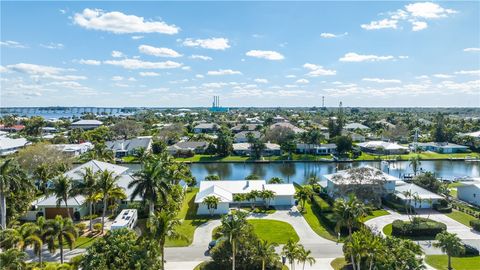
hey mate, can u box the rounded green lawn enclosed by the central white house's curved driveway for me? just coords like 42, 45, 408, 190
248, 219, 300, 244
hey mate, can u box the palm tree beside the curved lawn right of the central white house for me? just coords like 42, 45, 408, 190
333, 194, 367, 238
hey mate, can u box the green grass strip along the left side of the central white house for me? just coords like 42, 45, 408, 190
165, 188, 218, 247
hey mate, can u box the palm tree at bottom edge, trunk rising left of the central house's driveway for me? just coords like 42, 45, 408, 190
147, 211, 182, 270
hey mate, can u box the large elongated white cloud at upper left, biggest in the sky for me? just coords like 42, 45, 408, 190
73, 8, 180, 35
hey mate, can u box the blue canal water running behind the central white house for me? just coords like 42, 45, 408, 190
122, 160, 480, 184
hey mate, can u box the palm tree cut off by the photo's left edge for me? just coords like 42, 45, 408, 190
0, 159, 34, 229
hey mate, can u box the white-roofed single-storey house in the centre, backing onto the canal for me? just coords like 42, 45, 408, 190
195, 180, 295, 215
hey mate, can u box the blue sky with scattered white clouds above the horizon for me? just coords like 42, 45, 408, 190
0, 1, 480, 107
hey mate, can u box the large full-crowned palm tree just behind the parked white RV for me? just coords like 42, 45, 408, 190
128, 159, 170, 215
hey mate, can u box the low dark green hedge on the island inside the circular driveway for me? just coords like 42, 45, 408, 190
392, 217, 447, 237
